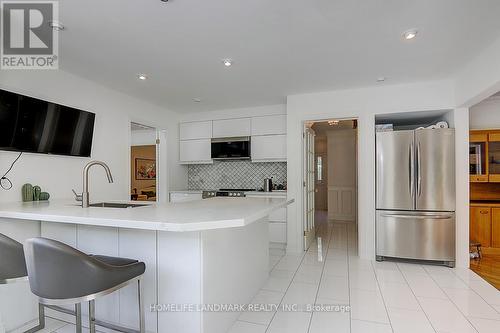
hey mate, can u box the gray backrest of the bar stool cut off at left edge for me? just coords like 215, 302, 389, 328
0, 234, 28, 284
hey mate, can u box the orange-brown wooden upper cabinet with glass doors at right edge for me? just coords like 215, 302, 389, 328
469, 130, 500, 183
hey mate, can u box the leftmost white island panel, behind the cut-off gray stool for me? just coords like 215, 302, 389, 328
0, 218, 40, 332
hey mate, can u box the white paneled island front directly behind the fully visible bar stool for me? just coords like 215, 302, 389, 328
42, 222, 157, 332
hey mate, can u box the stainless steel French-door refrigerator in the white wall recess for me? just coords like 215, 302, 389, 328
376, 128, 455, 266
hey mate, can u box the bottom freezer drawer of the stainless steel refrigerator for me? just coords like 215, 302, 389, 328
376, 210, 455, 262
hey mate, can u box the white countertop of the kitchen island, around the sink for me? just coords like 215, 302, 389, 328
0, 197, 293, 232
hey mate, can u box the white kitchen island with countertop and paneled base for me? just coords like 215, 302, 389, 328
0, 198, 291, 333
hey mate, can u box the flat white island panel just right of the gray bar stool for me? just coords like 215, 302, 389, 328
157, 231, 203, 333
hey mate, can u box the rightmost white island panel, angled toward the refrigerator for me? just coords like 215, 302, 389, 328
202, 217, 269, 333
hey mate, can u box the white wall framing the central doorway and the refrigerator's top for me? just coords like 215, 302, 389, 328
287, 81, 455, 259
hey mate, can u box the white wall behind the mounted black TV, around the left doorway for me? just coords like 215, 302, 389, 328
0, 70, 187, 201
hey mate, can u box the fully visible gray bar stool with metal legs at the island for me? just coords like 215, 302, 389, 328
24, 237, 146, 333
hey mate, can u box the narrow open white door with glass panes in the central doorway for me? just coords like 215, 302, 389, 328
303, 128, 316, 250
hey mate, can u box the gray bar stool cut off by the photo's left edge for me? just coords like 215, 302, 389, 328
0, 234, 45, 333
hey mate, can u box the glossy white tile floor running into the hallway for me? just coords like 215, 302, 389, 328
12, 218, 500, 333
